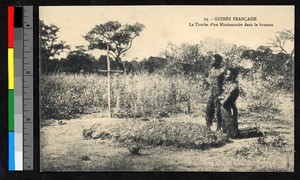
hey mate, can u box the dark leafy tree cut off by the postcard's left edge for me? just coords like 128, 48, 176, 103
39, 20, 70, 73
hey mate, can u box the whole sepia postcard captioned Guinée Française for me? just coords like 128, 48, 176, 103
39, 5, 295, 172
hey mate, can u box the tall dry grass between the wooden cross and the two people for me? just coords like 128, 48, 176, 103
112, 73, 206, 117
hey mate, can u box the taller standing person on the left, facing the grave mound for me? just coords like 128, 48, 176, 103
205, 54, 225, 131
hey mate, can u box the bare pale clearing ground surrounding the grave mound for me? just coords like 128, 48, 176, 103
40, 96, 294, 172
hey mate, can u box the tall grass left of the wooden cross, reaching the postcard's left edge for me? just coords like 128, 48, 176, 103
40, 74, 107, 120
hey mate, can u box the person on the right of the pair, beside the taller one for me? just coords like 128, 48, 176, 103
219, 68, 240, 138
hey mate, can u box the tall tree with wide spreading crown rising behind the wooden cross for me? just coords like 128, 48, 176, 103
83, 21, 145, 63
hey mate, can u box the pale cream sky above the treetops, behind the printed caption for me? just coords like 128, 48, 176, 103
39, 6, 294, 60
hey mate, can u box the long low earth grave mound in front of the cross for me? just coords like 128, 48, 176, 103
83, 120, 230, 149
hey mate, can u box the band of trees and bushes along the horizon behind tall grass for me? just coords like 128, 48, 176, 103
40, 21, 294, 92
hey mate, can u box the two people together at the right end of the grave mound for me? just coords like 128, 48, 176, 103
205, 54, 239, 138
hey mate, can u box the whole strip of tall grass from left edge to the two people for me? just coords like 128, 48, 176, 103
40, 73, 207, 119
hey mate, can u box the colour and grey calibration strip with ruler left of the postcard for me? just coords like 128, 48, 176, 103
8, 6, 33, 171
